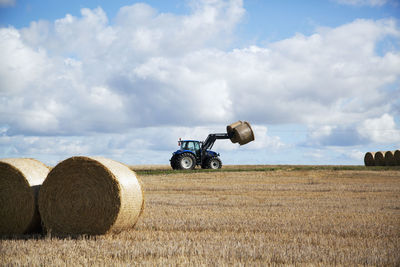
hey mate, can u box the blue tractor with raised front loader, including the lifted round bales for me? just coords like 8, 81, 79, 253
170, 121, 254, 170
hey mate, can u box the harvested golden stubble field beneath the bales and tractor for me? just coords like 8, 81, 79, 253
0, 166, 400, 266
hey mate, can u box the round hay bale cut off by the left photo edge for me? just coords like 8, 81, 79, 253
0, 158, 49, 235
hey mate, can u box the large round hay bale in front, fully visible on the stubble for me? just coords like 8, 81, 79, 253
39, 157, 144, 235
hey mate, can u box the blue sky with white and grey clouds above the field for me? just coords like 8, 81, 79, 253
0, 0, 400, 165
